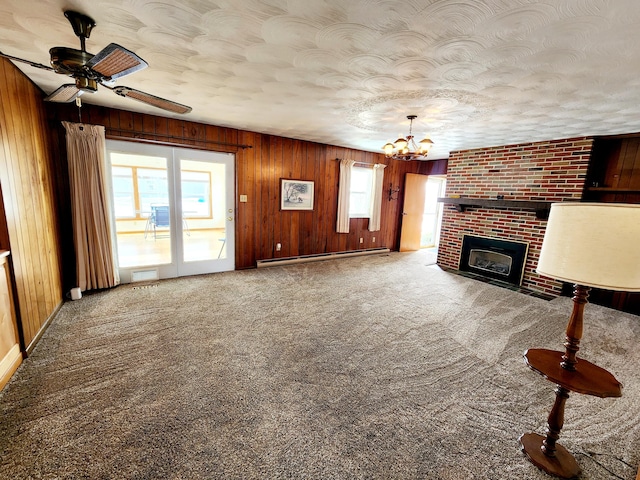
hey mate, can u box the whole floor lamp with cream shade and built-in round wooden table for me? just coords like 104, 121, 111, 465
520, 202, 640, 478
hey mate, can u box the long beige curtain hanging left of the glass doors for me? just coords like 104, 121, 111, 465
62, 122, 120, 291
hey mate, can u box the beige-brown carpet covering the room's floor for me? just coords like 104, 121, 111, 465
0, 252, 640, 480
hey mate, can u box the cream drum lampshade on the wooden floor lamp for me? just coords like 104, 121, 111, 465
536, 202, 640, 292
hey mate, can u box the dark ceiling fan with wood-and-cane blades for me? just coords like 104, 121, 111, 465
0, 10, 191, 113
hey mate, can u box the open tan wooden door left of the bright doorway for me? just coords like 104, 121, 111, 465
400, 173, 428, 252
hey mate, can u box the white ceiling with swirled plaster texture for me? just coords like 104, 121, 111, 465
0, 0, 640, 158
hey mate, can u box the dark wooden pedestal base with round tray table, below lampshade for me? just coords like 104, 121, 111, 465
519, 285, 622, 478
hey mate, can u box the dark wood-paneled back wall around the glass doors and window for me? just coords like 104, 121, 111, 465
48, 105, 446, 269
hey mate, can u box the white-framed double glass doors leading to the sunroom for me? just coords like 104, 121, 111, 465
107, 140, 235, 283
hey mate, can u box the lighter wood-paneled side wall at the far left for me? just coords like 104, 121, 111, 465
0, 58, 63, 350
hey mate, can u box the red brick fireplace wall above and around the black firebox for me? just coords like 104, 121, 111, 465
438, 137, 593, 295
